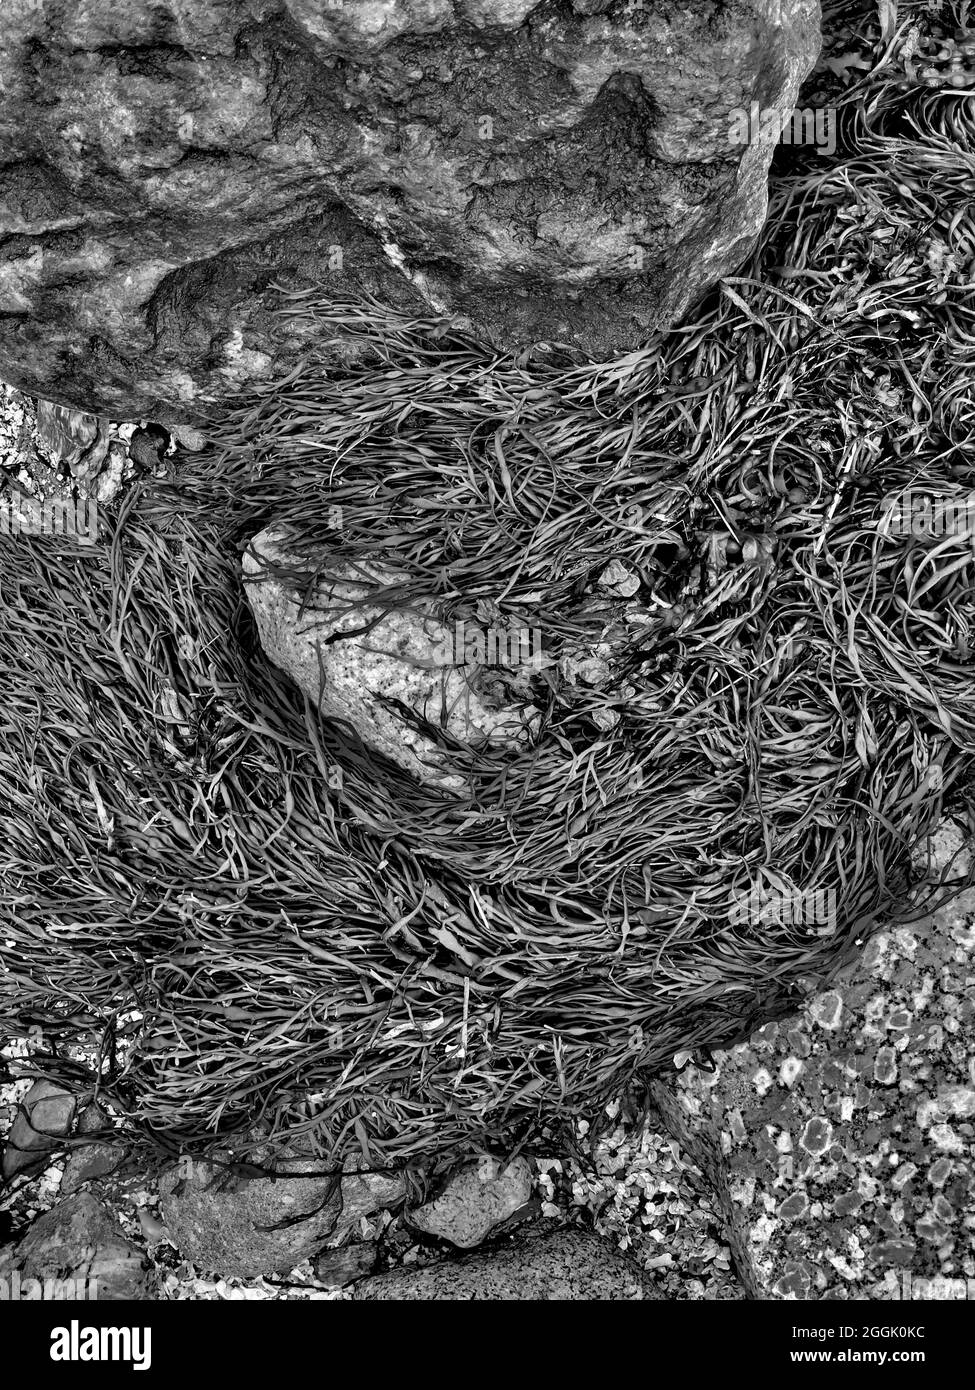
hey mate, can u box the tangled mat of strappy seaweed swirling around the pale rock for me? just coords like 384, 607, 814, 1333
0, 0, 975, 1166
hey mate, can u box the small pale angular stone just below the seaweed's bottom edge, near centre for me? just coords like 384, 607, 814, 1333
409, 1158, 533, 1250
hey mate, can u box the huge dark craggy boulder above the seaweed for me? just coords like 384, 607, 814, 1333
0, 0, 819, 423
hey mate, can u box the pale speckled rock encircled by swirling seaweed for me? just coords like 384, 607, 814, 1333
243, 531, 533, 792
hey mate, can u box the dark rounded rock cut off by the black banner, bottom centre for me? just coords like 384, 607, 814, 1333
355, 1227, 659, 1302
